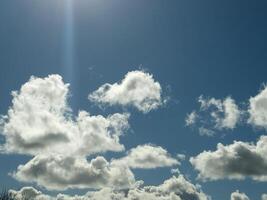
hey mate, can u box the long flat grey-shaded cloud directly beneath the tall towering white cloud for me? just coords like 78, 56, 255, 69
13, 154, 135, 190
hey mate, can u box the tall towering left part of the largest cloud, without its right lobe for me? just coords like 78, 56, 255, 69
3, 75, 70, 153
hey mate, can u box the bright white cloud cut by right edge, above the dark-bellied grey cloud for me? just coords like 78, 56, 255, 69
248, 86, 267, 130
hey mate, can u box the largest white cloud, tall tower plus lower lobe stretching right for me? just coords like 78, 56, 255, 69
2, 75, 129, 155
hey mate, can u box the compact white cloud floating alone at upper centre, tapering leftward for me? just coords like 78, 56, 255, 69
88, 71, 163, 113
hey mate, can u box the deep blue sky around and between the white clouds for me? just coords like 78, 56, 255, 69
0, 0, 267, 200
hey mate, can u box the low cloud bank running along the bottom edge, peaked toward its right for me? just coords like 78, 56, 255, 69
8, 175, 209, 200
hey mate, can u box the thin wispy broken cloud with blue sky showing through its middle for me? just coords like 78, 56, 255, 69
185, 96, 241, 136
